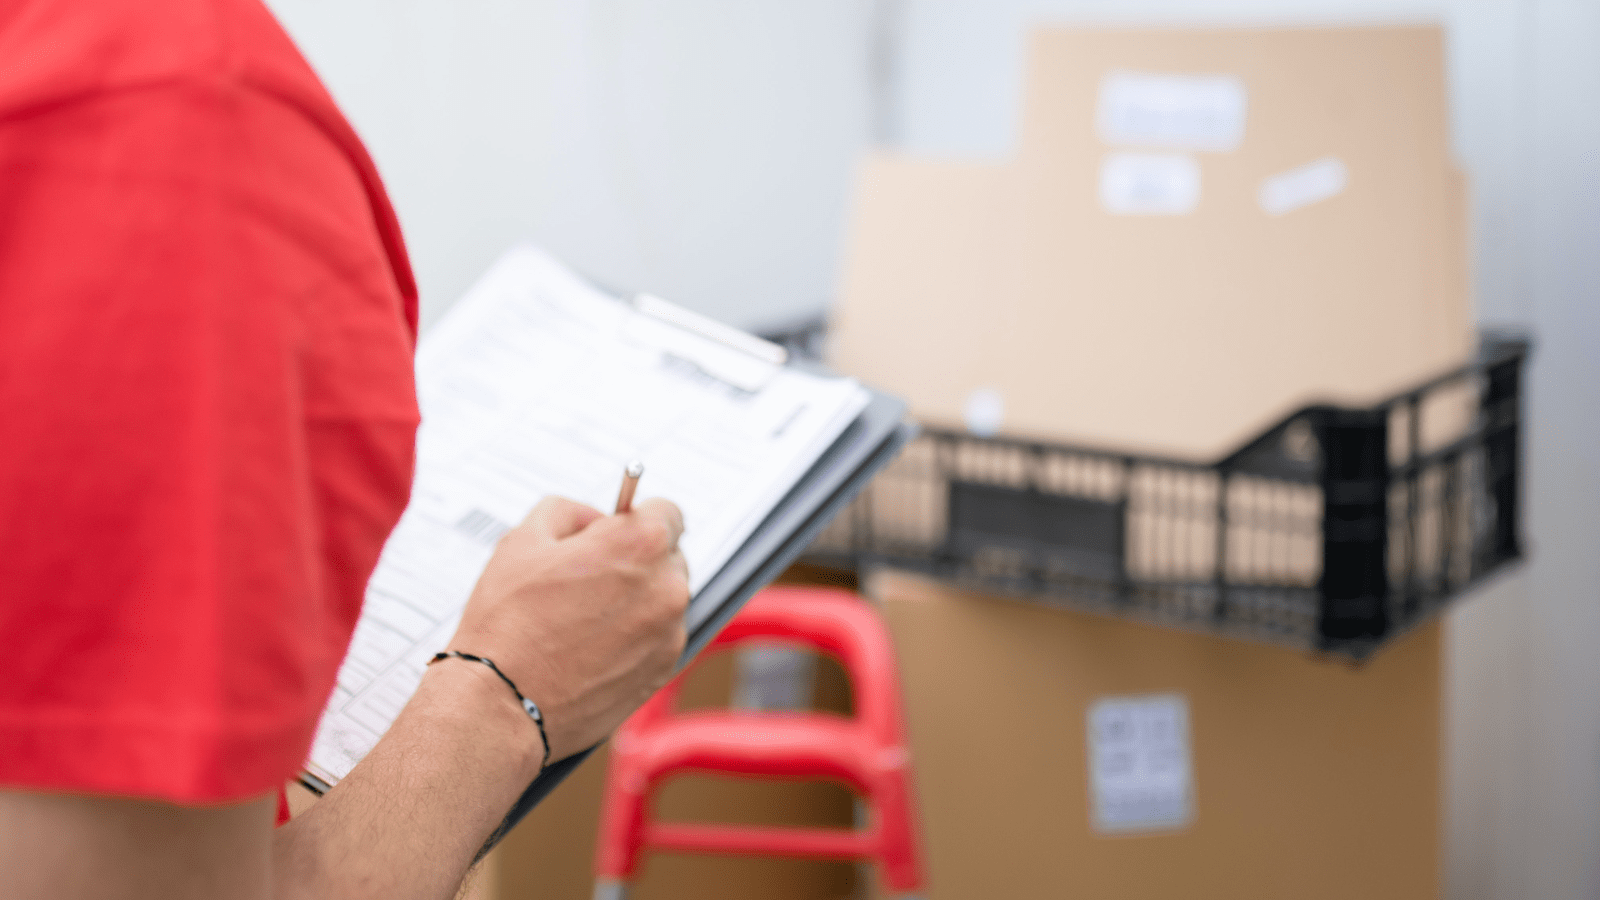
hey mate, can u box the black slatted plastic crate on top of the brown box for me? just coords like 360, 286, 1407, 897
810, 335, 1528, 658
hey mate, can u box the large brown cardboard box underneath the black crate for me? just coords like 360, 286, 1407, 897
867, 572, 1440, 900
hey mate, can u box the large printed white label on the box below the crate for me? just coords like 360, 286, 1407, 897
1088, 693, 1194, 833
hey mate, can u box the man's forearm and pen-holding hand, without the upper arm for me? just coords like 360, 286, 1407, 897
275, 500, 690, 900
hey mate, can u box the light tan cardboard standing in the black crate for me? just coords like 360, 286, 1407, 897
834, 27, 1472, 460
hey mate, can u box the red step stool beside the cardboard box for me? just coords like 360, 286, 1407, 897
595, 586, 923, 900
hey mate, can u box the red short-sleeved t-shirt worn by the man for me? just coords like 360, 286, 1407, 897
0, 0, 418, 802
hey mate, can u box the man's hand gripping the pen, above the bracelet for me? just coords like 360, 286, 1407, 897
440, 498, 690, 761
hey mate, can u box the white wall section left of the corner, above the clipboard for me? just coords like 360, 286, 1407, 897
269, 0, 874, 327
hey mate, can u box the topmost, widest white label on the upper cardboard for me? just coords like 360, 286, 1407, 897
1096, 72, 1248, 151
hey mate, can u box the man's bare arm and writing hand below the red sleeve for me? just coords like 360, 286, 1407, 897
0, 500, 688, 900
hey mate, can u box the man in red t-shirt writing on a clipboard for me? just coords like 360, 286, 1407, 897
0, 0, 688, 900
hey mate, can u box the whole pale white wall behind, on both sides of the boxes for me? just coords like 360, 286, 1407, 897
272, 0, 1600, 900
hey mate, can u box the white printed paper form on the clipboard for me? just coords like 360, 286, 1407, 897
307, 248, 869, 785
